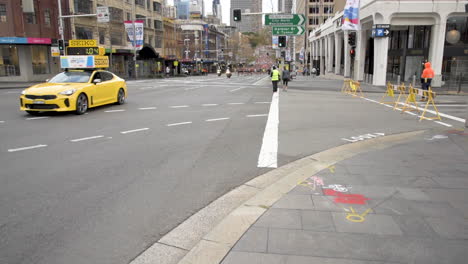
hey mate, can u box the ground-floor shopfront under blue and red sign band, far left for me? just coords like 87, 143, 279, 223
0, 37, 60, 82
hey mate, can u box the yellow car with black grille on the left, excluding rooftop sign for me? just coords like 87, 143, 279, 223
20, 70, 127, 115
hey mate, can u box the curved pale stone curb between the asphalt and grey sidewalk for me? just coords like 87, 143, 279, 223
130, 130, 425, 264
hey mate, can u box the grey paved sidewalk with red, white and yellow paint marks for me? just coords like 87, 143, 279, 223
222, 130, 468, 264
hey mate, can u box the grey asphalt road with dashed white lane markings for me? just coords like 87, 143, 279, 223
0, 75, 466, 264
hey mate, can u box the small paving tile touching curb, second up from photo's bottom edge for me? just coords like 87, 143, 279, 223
233, 226, 268, 252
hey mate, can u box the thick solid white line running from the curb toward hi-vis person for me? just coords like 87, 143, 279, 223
257, 93, 279, 168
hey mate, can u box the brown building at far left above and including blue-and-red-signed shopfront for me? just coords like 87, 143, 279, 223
0, 0, 67, 82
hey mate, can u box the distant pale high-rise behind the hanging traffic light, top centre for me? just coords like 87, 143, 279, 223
230, 0, 262, 32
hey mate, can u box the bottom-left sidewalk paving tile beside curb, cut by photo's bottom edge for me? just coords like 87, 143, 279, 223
221, 251, 286, 264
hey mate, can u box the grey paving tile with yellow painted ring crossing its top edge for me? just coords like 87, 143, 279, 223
332, 212, 403, 236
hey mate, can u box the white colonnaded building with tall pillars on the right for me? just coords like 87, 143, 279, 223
309, 0, 468, 87
